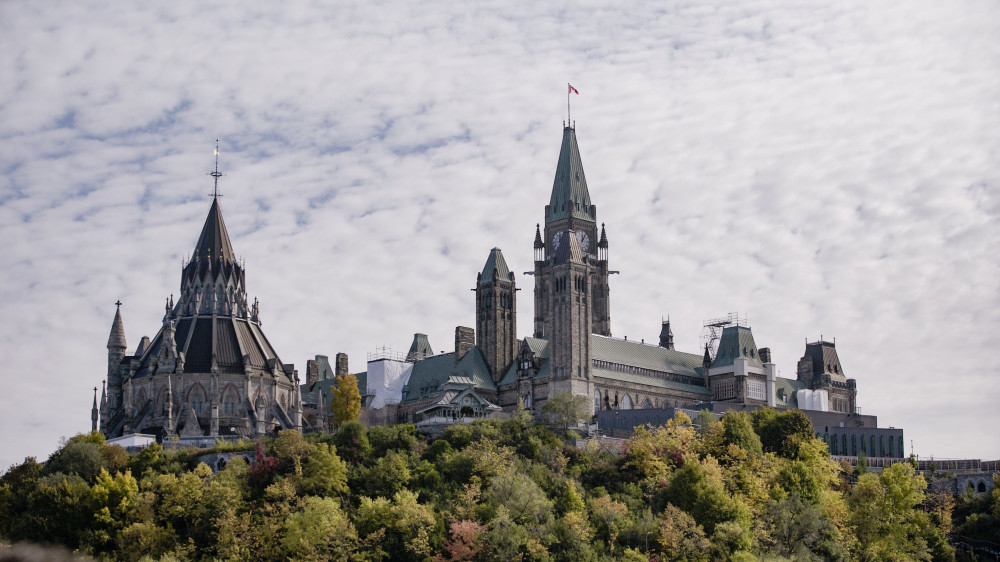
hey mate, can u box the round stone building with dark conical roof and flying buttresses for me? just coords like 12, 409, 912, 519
95, 172, 302, 440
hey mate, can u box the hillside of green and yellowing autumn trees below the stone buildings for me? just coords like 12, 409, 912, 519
0, 404, 1000, 561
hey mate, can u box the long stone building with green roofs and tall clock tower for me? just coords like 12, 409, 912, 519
374, 122, 868, 425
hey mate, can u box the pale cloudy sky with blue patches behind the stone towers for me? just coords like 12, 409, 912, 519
0, 0, 1000, 470
